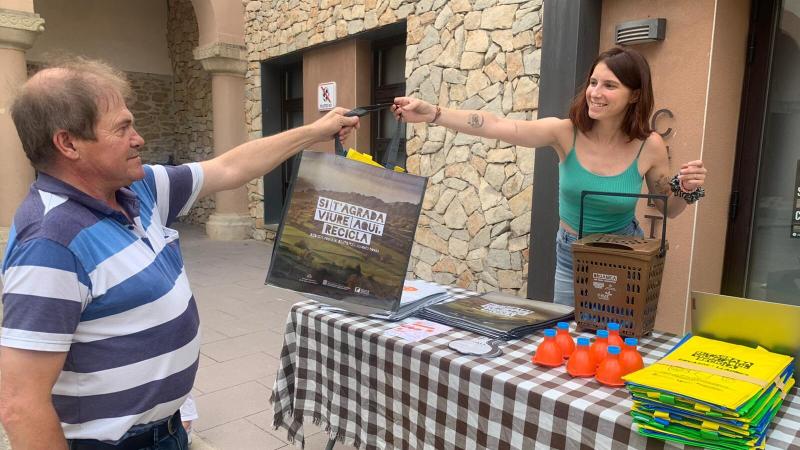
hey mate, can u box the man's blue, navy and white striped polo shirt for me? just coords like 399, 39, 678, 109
0, 163, 203, 442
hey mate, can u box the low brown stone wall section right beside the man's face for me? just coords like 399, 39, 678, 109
126, 72, 177, 164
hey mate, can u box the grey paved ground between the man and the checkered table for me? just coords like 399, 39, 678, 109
0, 225, 352, 450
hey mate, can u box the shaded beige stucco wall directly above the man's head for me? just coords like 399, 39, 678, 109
27, 0, 172, 74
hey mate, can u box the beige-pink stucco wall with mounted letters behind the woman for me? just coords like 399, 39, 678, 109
600, 0, 749, 333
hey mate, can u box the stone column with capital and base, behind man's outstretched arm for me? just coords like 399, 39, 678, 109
194, 42, 253, 240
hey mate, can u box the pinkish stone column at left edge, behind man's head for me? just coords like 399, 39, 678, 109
0, 7, 44, 258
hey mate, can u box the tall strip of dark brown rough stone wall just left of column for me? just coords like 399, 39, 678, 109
167, 0, 215, 224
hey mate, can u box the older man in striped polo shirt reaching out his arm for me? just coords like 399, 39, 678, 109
0, 60, 358, 450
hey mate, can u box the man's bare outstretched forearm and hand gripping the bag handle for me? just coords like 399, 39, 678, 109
200, 108, 358, 197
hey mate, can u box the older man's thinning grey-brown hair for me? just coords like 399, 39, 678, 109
11, 57, 131, 169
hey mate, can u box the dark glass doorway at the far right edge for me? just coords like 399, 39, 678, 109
722, 0, 800, 305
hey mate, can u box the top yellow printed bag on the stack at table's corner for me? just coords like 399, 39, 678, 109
623, 336, 792, 410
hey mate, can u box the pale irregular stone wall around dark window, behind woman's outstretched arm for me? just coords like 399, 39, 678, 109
244, 0, 542, 296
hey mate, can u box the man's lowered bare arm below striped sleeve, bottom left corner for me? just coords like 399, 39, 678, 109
0, 347, 67, 450
